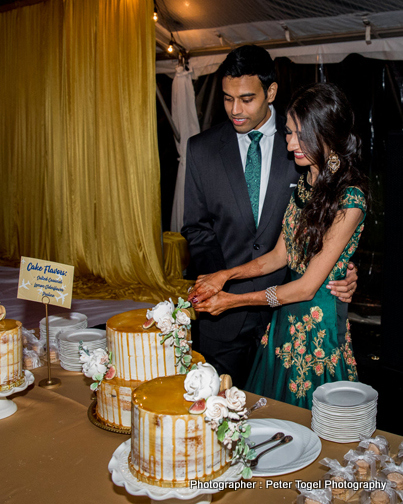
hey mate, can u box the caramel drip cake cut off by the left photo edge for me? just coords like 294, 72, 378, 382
0, 319, 25, 392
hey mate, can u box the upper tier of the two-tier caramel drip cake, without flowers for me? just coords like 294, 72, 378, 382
106, 309, 190, 382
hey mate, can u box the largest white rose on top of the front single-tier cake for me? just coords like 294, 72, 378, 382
183, 362, 220, 401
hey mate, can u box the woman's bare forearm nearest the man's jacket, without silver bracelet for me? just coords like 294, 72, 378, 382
188, 233, 287, 303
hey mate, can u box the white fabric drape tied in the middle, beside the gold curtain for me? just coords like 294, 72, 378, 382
171, 67, 200, 232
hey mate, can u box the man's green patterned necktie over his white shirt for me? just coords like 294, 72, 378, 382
245, 131, 263, 229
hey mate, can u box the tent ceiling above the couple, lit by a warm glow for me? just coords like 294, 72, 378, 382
156, 0, 403, 59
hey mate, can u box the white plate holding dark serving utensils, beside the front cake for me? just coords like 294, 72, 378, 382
249, 418, 322, 477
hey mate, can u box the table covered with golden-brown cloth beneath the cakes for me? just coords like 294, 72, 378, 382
0, 364, 403, 504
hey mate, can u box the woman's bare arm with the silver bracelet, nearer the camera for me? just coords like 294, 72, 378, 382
195, 208, 363, 315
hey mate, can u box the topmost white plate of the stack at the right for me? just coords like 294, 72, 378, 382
313, 381, 378, 408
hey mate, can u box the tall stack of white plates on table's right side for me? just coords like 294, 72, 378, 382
311, 381, 378, 443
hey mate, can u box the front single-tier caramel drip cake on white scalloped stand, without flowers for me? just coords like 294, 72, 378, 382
129, 375, 231, 488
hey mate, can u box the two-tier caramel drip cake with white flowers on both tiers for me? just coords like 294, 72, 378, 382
81, 298, 195, 430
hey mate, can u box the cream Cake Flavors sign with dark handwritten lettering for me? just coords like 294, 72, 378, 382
17, 257, 74, 308
